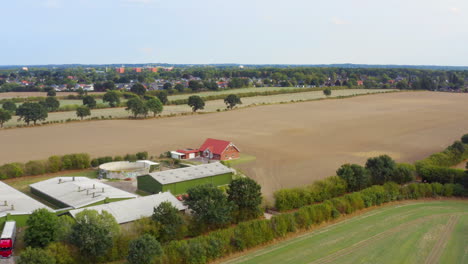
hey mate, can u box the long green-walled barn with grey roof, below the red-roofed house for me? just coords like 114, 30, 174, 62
137, 162, 234, 194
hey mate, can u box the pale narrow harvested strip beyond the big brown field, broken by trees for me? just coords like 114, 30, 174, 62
0, 88, 395, 127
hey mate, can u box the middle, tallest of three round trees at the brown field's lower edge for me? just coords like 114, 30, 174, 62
366, 155, 397, 184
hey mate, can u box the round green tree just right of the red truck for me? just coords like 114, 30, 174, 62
24, 208, 59, 248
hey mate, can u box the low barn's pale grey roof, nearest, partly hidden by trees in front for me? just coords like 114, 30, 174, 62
70, 192, 186, 224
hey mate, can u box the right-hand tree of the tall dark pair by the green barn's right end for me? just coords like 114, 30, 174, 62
227, 177, 262, 222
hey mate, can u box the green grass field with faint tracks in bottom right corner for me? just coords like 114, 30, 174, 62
225, 200, 468, 264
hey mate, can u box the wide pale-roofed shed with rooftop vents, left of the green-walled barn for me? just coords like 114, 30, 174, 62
29, 177, 137, 208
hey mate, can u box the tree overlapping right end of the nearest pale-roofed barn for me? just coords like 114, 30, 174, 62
152, 202, 185, 242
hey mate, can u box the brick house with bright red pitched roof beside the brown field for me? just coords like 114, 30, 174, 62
199, 138, 240, 160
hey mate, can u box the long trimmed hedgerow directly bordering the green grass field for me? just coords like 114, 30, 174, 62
158, 182, 465, 264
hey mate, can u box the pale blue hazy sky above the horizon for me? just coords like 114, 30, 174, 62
0, 0, 468, 66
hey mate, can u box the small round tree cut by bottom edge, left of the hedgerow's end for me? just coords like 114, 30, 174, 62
127, 234, 162, 264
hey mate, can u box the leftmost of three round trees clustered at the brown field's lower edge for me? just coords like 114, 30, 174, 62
336, 164, 371, 192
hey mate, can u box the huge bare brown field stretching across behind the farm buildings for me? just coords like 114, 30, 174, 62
0, 92, 468, 195
